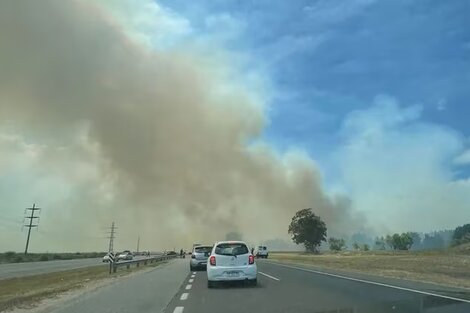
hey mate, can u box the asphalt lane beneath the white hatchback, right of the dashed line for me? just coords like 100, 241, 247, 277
166, 261, 470, 313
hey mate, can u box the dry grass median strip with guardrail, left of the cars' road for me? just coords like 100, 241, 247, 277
0, 262, 162, 312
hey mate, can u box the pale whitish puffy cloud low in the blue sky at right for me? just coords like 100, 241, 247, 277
338, 97, 470, 231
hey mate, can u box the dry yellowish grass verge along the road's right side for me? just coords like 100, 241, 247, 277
270, 250, 470, 289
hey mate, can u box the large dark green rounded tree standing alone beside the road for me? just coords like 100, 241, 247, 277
288, 208, 326, 252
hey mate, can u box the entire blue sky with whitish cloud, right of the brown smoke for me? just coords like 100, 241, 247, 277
149, 0, 470, 230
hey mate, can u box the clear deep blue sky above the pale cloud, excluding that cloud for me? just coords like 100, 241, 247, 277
158, 0, 470, 180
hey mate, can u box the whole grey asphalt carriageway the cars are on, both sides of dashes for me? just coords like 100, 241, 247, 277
7, 259, 470, 313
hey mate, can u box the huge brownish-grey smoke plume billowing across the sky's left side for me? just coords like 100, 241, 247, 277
0, 1, 360, 250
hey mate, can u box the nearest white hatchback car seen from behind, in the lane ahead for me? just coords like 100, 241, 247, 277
207, 241, 258, 288
